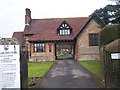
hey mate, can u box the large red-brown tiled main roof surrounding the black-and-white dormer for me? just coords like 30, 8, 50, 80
24, 17, 91, 41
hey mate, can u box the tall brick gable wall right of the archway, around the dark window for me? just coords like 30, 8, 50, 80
75, 20, 101, 60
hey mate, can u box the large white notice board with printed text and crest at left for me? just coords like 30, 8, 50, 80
0, 45, 20, 90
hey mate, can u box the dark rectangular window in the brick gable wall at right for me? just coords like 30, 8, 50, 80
89, 33, 98, 46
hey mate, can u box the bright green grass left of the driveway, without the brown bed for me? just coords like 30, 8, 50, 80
28, 62, 53, 78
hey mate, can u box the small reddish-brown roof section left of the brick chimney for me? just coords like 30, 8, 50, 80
12, 32, 25, 46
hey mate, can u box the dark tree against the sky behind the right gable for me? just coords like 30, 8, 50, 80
95, 0, 120, 24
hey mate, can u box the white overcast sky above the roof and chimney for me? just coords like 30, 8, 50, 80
0, 0, 111, 38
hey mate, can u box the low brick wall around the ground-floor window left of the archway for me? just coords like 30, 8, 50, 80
29, 43, 55, 62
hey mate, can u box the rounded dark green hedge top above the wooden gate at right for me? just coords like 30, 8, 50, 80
99, 24, 120, 47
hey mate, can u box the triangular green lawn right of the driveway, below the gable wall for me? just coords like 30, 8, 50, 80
79, 60, 104, 79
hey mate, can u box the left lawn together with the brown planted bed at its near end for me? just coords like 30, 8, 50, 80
28, 62, 54, 87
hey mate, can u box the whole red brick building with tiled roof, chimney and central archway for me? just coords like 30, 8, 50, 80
13, 9, 103, 62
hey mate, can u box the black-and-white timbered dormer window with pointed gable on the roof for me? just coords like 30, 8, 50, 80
57, 21, 72, 36
